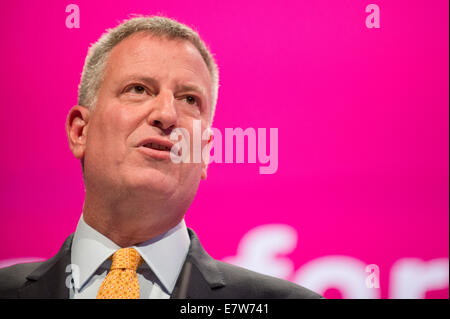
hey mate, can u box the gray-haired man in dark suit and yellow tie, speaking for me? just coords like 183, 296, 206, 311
0, 17, 320, 299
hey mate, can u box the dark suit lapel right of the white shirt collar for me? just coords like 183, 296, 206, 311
171, 228, 226, 299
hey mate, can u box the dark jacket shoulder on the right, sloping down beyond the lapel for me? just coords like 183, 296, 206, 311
216, 260, 323, 299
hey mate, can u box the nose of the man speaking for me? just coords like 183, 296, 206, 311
147, 91, 178, 135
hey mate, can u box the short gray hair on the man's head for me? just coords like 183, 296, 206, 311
78, 16, 219, 125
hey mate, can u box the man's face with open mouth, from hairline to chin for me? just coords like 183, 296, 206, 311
80, 33, 211, 208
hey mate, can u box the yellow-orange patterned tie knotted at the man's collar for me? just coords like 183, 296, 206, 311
97, 248, 143, 299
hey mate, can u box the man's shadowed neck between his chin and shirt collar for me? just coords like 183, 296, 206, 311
83, 194, 184, 248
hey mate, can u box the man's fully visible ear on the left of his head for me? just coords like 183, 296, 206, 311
66, 105, 90, 160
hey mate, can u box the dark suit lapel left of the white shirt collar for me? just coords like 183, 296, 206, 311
19, 234, 73, 299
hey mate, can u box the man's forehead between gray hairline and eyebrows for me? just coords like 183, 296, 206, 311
105, 32, 212, 95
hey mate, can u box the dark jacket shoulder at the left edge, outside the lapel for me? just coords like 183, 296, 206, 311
0, 262, 42, 298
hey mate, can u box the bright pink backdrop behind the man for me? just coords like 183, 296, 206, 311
0, 0, 449, 298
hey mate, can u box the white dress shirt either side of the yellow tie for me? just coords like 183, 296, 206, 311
68, 215, 191, 299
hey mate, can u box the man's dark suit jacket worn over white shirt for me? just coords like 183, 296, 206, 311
0, 229, 321, 299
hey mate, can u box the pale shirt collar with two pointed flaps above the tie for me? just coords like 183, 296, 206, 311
71, 215, 190, 293
